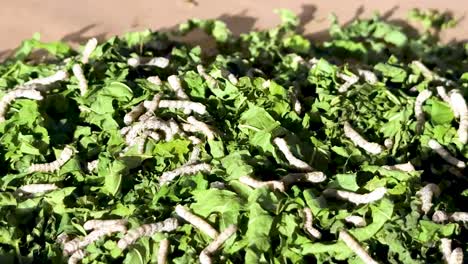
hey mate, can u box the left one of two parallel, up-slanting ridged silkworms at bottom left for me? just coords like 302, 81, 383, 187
63, 225, 127, 256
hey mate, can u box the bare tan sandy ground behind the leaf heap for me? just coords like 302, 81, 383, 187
0, 0, 468, 57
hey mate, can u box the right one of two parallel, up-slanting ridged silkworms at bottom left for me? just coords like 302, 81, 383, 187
117, 218, 179, 250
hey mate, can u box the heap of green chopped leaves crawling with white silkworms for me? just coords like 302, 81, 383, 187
0, 10, 468, 264
